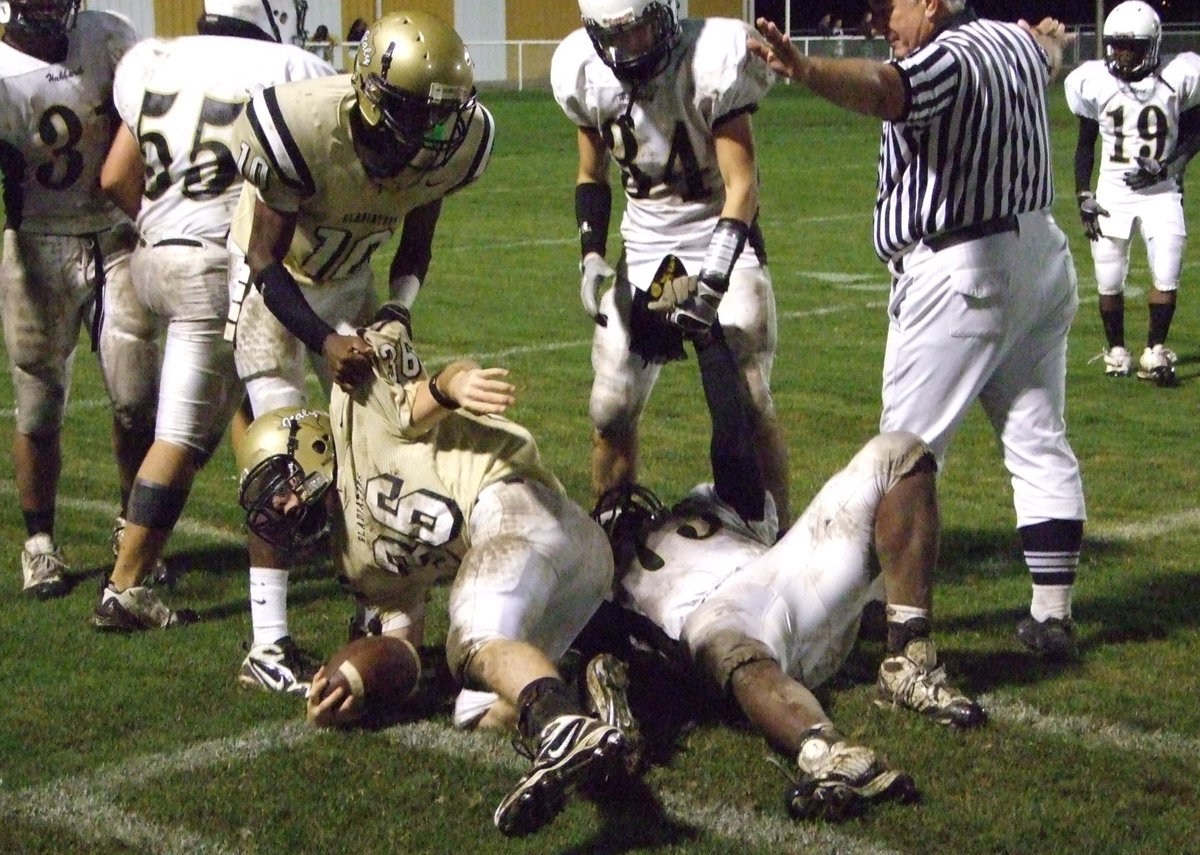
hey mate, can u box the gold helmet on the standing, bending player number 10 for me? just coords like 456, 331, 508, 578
352, 12, 475, 169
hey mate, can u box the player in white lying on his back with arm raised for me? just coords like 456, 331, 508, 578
593, 324, 986, 819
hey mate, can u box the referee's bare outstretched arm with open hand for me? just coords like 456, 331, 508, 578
746, 18, 905, 121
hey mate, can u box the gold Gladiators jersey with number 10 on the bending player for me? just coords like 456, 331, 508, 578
226, 74, 494, 285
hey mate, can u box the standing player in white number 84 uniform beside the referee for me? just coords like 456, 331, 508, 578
551, 0, 788, 527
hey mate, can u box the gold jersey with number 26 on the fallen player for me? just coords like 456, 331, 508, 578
329, 321, 563, 611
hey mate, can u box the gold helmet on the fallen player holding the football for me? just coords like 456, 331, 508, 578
238, 407, 335, 551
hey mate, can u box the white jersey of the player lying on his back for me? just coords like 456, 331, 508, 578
617, 484, 778, 641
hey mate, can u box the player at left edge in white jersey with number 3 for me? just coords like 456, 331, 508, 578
0, 0, 158, 598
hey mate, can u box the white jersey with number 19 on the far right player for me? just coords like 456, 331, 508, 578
1064, 53, 1200, 198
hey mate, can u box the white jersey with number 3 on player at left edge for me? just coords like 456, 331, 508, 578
0, 12, 137, 235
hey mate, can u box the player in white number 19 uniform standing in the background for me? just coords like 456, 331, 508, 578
1066, 0, 1200, 385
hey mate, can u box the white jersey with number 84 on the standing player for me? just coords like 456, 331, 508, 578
551, 18, 774, 289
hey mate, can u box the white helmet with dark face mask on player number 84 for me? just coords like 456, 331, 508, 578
580, 0, 680, 82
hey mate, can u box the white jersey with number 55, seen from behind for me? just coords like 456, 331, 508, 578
113, 36, 336, 245
